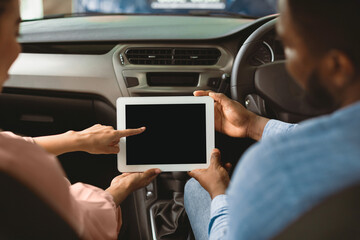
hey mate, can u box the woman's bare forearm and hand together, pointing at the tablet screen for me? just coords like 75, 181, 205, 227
33, 124, 145, 155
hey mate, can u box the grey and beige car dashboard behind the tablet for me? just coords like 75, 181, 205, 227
5, 16, 284, 106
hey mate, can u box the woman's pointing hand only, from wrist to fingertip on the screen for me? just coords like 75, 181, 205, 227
77, 124, 145, 154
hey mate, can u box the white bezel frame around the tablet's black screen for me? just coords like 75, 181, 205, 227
116, 96, 215, 172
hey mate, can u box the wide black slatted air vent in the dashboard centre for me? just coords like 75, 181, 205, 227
125, 48, 221, 65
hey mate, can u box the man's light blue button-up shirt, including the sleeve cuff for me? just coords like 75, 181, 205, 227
209, 103, 360, 240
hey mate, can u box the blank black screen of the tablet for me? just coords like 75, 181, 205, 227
125, 103, 206, 165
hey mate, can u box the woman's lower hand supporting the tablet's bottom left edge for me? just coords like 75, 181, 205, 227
105, 168, 161, 206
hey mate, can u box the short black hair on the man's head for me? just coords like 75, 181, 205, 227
287, 0, 360, 72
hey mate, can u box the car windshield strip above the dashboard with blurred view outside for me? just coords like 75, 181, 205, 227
21, 0, 277, 20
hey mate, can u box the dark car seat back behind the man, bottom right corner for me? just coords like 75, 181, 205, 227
274, 184, 360, 240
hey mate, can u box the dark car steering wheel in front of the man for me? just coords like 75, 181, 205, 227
230, 18, 323, 122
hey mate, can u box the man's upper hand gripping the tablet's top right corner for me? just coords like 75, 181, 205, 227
194, 91, 269, 140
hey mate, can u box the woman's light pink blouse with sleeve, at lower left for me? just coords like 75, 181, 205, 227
0, 132, 121, 240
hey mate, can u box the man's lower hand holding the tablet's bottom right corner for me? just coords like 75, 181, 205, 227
189, 149, 231, 199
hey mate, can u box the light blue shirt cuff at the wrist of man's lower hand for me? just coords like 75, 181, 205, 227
209, 195, 229, 240
